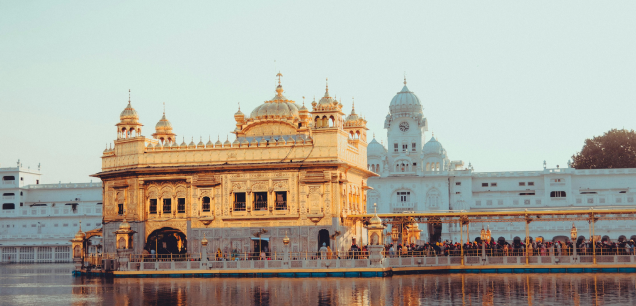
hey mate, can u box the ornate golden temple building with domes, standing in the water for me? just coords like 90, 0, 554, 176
94, 74, 377, 254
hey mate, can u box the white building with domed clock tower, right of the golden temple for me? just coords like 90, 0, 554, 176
367, 82, 636, 241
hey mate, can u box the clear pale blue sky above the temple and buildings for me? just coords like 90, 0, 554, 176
0, 1, 636, 183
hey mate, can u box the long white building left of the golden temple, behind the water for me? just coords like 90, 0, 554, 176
0, 162, 102, 262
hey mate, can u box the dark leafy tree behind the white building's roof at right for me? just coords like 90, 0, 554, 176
572, 129, 636, 169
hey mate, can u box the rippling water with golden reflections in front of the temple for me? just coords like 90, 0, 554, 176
0, 264, 636, 306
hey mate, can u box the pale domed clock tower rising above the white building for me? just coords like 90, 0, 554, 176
384, 79, 428, 176
